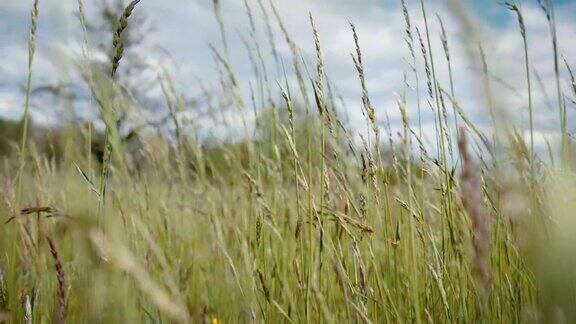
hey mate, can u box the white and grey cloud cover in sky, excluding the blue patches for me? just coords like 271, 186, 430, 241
0, 0, 576, 151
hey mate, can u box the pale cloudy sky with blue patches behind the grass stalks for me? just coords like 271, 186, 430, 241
0, 0, 576, 151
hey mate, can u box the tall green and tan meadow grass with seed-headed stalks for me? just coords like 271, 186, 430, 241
0, 1, 576, 323
